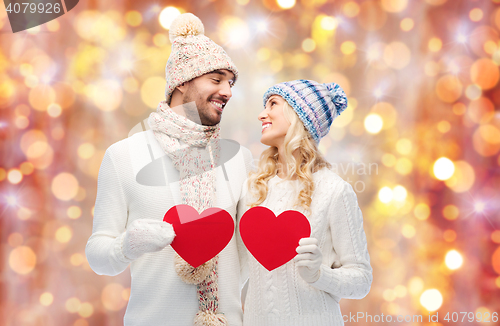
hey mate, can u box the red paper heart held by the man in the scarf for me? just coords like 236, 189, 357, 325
163, 205, 234, 267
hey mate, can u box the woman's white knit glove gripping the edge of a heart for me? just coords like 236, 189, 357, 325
293, 238, 323, 283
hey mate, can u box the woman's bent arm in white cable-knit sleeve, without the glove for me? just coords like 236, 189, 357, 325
310, 180, 373, 299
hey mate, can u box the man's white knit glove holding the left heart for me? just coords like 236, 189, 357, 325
122, 219, 175, 260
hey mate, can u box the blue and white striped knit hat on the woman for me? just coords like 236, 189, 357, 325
264, 79, 347, 144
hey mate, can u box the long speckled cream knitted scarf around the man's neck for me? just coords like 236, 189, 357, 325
148, 101, 227, 326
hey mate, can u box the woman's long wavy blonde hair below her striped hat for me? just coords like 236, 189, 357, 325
248, 101, 331, 213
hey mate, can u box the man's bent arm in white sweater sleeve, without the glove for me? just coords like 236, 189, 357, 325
85, 149, 132, 276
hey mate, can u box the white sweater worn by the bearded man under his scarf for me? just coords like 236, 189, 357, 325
86, 130, 252, 326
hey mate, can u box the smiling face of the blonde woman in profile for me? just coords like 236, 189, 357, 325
259, 95, 290, 147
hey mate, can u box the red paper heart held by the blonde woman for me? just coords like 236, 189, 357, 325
240, 206, 311, 271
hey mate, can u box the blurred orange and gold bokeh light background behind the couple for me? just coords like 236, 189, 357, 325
0, 0, 500, 326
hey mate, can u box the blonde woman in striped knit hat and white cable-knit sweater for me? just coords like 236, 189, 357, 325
243, 80, 372, 326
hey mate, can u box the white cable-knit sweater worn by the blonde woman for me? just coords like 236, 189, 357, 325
238, 168, 372, 326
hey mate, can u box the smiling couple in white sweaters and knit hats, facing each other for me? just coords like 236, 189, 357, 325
86, 14, 372, 326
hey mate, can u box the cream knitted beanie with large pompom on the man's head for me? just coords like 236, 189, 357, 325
165, 13, 238, 104
